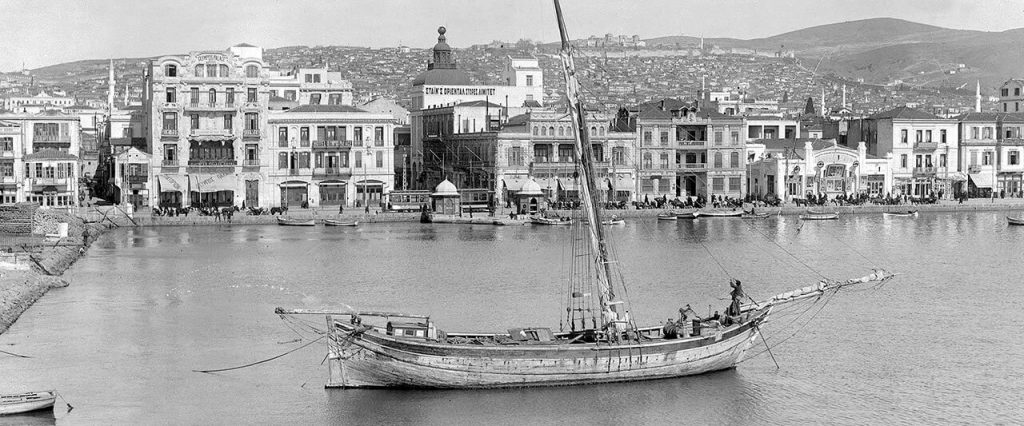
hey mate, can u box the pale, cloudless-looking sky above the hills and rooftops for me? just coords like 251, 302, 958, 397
0, 0, 1024, 71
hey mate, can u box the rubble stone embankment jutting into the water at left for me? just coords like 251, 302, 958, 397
0, 210, 108, 334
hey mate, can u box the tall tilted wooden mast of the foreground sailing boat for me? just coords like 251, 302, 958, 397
554, 0, 617, 324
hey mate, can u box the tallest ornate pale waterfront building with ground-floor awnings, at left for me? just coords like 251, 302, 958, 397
143, 45, 276, 207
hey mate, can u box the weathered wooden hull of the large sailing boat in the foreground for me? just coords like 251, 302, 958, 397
327, 310, 768, 388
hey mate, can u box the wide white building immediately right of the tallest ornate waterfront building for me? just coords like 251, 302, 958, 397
266, 104, 395, 208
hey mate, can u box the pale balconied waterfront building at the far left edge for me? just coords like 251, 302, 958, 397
0, 111, 81, 207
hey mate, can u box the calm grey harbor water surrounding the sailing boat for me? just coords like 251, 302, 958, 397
0, 212, 1024, 424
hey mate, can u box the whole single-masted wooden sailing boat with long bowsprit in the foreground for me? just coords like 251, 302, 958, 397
275, 0, 892, 388
